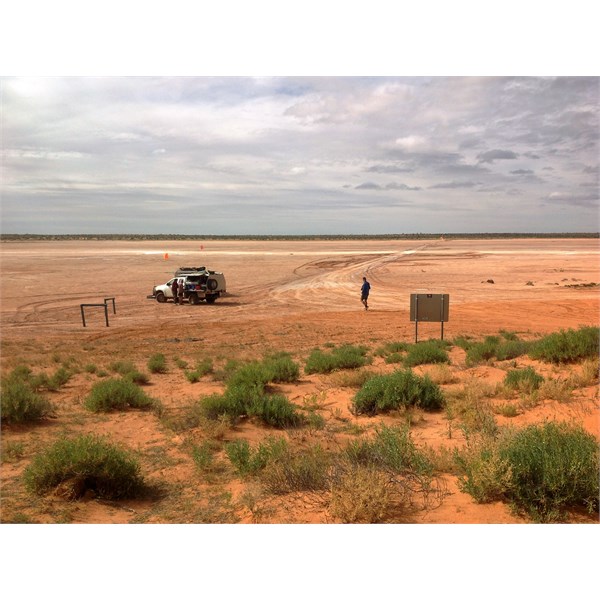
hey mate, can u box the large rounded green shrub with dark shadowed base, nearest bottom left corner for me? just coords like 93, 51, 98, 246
24, 435, 143, 499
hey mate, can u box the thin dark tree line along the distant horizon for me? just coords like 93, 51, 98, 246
0, 232, 600, 242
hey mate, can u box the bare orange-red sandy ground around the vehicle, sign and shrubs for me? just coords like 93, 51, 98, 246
0, 239, 600, 524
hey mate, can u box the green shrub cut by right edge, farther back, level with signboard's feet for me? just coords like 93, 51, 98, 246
529, 327, 600, 364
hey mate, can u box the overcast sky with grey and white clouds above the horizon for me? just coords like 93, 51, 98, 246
1, 76, 600, 235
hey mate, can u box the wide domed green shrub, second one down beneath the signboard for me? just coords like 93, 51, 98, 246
353, 369, 444, 414
